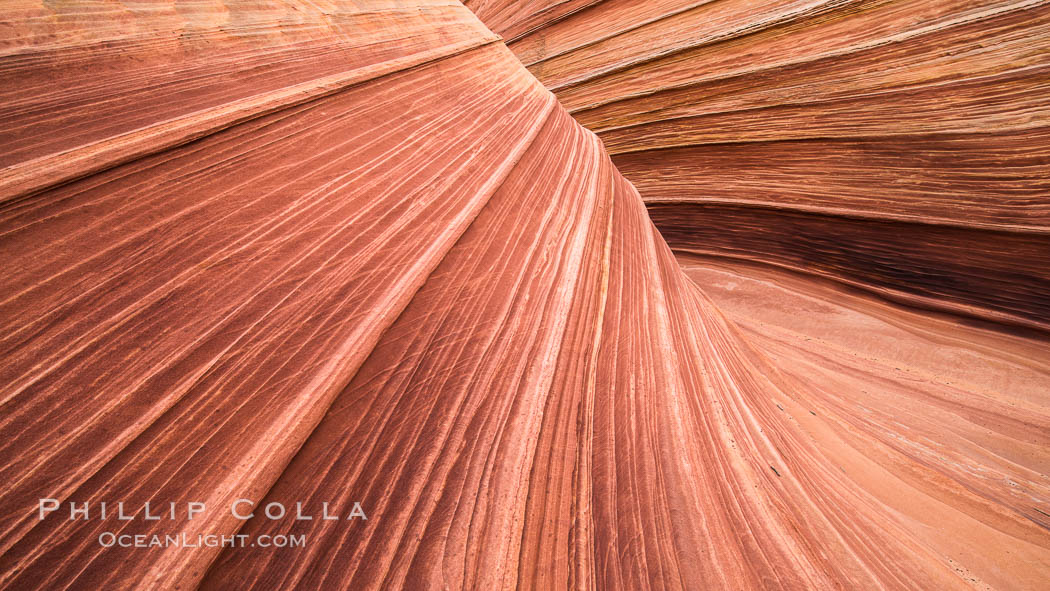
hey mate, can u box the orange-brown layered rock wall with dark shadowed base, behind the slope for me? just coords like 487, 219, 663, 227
466, 0, 1050, 331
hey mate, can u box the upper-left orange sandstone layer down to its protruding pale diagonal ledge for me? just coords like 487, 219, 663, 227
0, 0, 499, 199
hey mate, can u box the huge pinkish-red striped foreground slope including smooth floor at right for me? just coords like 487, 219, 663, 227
0, 0, 1050, 590
